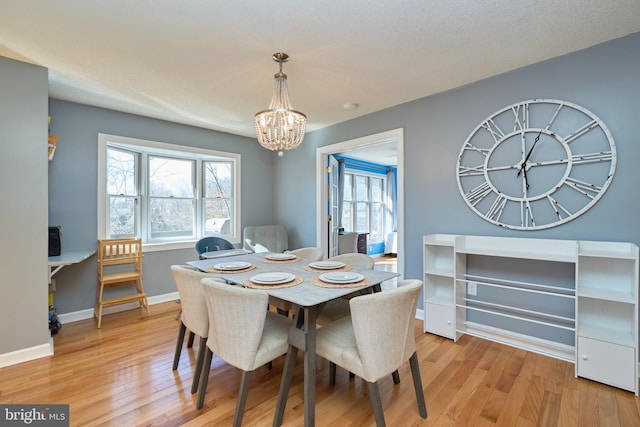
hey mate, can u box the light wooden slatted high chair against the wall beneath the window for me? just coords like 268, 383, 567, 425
95, 238, 150, 328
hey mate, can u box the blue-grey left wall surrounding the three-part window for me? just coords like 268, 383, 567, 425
49, 99, 277, 314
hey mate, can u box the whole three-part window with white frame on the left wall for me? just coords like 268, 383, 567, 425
98, 134, 240, 250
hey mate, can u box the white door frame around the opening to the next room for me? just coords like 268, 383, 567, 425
316, 128, 404, 278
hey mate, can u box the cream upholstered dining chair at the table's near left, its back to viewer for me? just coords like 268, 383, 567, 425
197, 279, 293, 426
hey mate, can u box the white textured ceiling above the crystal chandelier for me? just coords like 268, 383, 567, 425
0, 0, 640, 150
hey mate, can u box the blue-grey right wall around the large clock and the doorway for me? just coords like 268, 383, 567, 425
275, 33, 640, 284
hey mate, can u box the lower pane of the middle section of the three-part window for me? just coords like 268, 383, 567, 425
149, 198, 195, 239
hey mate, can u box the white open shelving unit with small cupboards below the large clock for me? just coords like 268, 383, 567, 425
423, 234, 638, 395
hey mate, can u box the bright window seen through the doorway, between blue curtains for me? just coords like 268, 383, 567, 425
342, 173, 385, 240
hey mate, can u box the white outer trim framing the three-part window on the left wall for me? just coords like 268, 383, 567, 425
97, 133, 242, 252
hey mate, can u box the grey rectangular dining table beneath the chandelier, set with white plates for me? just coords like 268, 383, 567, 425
187, 253, 399, 426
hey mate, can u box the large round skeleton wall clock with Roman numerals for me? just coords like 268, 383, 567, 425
456, 99, 616, 230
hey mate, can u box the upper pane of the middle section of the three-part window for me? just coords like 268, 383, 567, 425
149, 156, 195, 197
